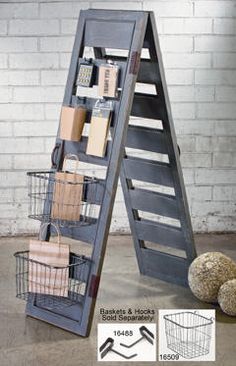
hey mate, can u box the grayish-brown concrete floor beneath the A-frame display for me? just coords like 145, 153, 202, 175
0, 234, 236, 366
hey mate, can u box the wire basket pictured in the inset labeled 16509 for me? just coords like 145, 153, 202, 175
164, 311, 213, 358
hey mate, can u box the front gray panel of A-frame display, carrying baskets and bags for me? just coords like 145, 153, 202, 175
26, 10, 148, 336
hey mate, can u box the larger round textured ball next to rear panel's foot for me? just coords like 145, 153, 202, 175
188, 252, 236, 302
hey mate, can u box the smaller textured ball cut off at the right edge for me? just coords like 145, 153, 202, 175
218, 279, 236, 316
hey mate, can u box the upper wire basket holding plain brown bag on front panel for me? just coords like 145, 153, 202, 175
27, 170, 99, 227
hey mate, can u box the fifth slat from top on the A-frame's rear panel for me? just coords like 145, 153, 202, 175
123, 156, 174, 187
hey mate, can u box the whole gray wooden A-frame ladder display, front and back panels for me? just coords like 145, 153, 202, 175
26, 9, 196, 336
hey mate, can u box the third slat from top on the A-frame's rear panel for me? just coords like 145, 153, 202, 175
131, 93, 165, 120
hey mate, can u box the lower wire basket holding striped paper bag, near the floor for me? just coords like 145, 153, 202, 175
14, 251, 90, 309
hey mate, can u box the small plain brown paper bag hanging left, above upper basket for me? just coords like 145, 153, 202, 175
60, 106, 86, 141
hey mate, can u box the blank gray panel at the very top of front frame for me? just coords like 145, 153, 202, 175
84, 19, 134, 50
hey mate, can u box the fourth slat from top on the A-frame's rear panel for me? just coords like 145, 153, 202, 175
126, 125, 168, 154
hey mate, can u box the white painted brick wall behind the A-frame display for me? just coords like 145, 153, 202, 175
0, 0, 236, 235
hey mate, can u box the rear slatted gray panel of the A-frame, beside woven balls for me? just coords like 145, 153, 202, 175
119, 9, 196, 292
